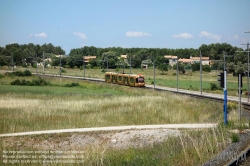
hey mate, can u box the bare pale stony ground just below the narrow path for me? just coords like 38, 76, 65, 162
3, 129, 180, 151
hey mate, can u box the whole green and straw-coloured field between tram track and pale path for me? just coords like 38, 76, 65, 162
0, 73, 222, 133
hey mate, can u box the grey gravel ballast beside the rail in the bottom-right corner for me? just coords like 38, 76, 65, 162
203, 130, 250, 166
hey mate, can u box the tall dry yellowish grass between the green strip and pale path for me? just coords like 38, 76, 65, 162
0, 87, 222, 133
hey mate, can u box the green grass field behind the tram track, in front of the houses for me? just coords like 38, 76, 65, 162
0, 67, 247, 97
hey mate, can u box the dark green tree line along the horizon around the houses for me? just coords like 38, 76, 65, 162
0, 43, 247, 73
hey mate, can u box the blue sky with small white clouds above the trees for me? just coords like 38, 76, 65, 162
0, 0, 250, 54
